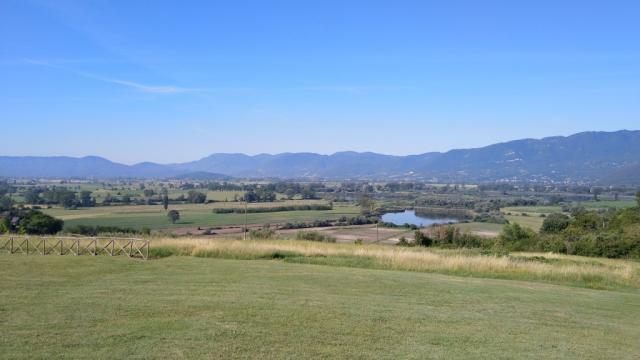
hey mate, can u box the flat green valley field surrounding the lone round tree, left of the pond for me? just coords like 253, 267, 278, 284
44, 200, 359, 230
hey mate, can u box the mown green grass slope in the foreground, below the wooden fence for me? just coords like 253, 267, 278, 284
0, 254, 640, 359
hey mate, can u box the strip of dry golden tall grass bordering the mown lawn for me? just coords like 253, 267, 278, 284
151, 238, 640, 288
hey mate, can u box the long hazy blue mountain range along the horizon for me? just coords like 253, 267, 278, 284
0, 130, 640, 185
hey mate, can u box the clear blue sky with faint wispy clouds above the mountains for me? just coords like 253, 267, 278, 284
0, 0, 640, 163
